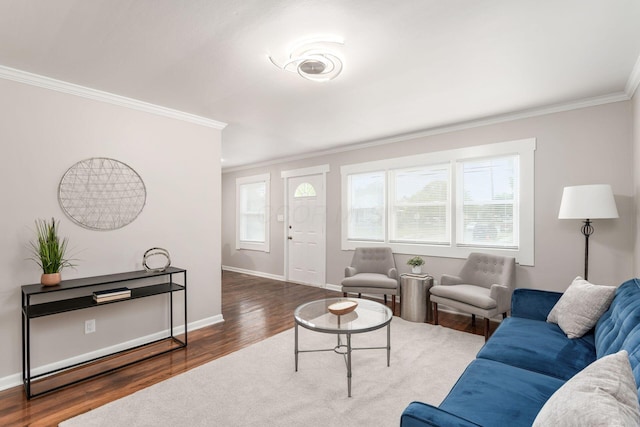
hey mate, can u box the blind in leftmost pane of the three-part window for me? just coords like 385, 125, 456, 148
347, 171, 385, 242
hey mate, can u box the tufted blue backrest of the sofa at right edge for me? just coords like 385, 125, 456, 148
595, 279, 640, 400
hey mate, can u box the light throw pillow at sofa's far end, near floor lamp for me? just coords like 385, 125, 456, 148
547, 276, 616, 338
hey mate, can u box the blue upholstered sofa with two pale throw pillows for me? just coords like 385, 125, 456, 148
400, 279, 640, 427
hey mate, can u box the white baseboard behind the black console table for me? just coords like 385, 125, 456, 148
0, 314, 224, 391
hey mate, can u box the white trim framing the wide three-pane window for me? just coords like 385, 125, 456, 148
340, 138, 536, 266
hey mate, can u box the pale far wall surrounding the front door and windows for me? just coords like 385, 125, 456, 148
222, 102, 635, 291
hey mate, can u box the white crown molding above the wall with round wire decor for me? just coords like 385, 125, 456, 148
0, 65, 227, 130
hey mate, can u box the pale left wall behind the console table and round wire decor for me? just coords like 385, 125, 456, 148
0, 79, 222, 388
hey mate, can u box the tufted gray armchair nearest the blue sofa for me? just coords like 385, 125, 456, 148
431, 253, 516, 340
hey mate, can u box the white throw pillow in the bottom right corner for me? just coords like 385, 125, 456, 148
533, 350, 640, 427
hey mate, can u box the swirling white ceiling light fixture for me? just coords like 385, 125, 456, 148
269, 37, 344, 82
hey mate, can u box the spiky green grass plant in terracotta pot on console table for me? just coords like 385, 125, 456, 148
30, 218, 73, 286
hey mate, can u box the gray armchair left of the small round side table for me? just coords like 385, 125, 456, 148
342, 248, 400, 312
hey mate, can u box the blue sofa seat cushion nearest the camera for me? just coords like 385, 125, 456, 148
440, 360, 564, 427
